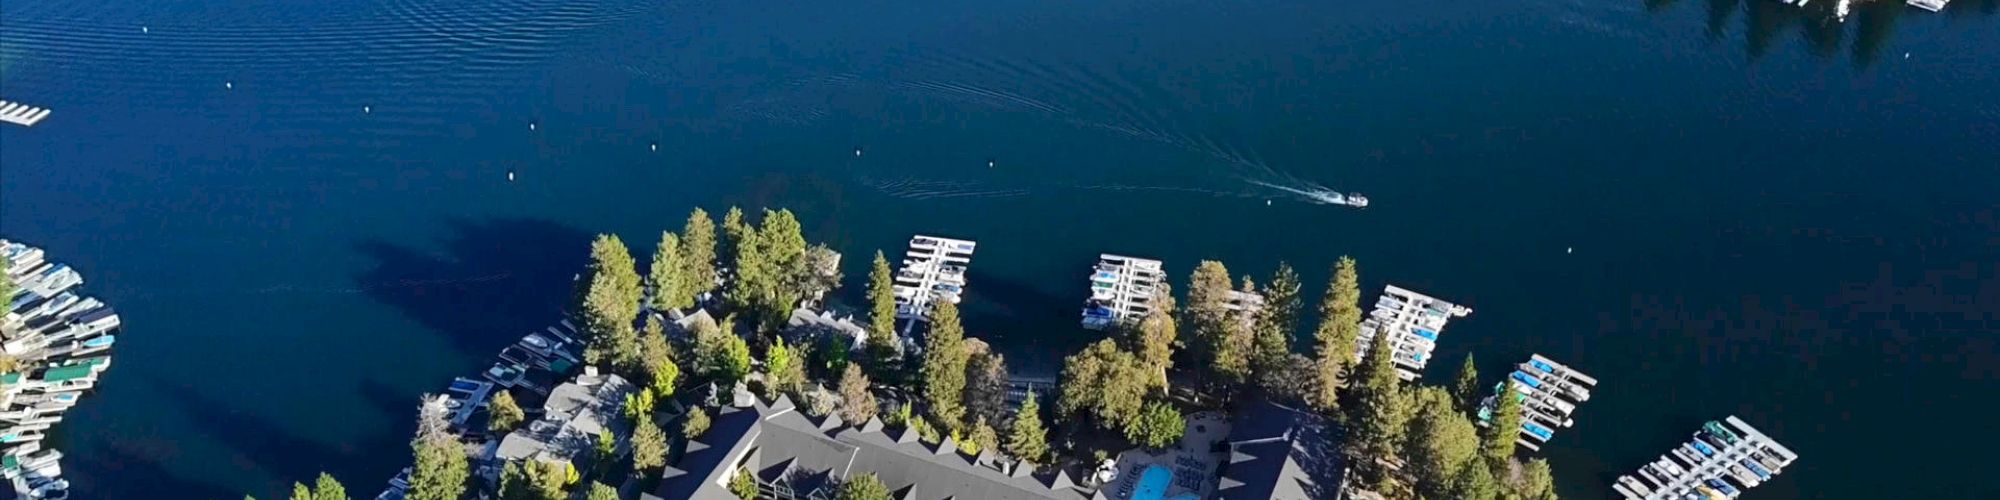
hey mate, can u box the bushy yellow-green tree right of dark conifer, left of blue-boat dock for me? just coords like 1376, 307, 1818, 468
1406, 388, 1486, 498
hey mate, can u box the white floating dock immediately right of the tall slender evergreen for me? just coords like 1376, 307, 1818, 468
1354, 284, 1472, 380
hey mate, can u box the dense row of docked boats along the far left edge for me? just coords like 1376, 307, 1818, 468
0, 240, 120, 500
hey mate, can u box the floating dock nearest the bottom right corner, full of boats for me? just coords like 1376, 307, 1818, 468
1612, 416, 1798, 500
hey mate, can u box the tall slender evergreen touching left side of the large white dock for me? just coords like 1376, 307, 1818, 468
1312, 256, 1362, 412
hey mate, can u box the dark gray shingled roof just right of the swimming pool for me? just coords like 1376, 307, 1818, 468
1216, 402, 1344, 500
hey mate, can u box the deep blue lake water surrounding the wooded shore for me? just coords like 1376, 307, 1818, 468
0, 0, 2000, 498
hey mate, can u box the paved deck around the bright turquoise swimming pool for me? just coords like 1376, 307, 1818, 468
1100, 412, 1230, 500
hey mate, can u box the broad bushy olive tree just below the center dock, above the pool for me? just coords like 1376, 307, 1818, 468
1056, 338, 1148, 430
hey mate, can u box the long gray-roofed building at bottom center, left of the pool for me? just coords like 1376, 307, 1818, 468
644, 386, 1094, 500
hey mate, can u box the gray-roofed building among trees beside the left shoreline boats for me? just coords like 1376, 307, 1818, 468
494, 368, 638, 464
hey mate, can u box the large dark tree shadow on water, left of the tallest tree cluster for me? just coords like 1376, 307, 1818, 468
356, 218, 592, 356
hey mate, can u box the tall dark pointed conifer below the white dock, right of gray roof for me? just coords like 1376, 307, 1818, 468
1348, 324, 1412, 490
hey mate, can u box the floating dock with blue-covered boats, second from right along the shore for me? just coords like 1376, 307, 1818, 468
1478, 354, 1598, 450
